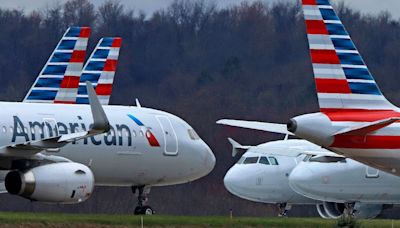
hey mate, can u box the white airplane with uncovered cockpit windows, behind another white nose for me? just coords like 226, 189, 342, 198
224, 138, 319, 216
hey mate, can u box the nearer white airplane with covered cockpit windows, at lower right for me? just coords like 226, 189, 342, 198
289, 154, 400, 218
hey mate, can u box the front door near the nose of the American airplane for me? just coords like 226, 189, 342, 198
156, 116, 178, 155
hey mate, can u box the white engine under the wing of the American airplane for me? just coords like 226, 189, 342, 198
5, 162, 94, 204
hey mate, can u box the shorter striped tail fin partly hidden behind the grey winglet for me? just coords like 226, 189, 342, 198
76, 37, 122, 105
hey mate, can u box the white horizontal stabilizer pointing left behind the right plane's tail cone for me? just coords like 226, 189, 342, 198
217, 119, 293, 135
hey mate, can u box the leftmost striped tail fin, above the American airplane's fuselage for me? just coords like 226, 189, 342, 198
23, 27, 90, 104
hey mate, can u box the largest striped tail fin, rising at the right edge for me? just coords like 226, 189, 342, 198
302, 0, 397, 113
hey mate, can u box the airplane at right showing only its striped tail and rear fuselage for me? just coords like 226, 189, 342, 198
287, 0, 400, 176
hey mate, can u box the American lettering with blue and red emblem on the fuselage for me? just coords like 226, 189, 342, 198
11, 115, 160, 147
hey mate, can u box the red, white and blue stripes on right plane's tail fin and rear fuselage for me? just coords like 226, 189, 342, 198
302, 0, 400, 151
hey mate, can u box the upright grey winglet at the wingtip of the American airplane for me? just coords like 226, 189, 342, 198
86, 81, 110, 132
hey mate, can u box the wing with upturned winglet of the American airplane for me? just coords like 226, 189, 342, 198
0, 82, 110, 156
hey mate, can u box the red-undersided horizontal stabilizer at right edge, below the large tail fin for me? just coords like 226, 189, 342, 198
334, 117, 400, 136
